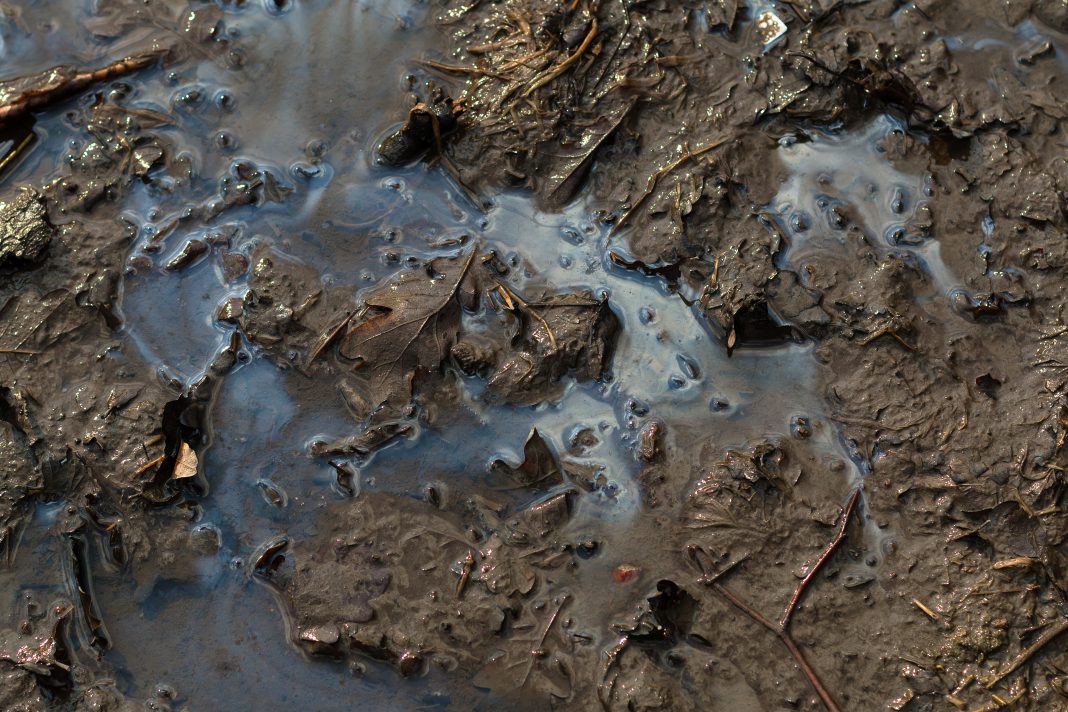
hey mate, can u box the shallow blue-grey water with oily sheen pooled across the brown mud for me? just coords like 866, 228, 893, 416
0, 1, 875, 710
